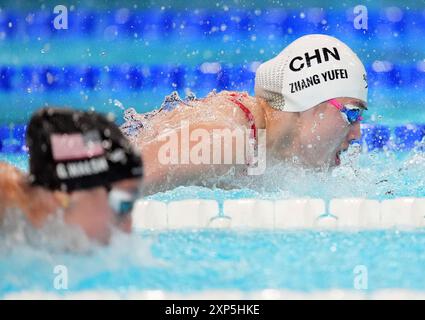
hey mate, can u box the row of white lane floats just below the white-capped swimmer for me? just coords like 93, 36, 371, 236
133, 198, 425, 230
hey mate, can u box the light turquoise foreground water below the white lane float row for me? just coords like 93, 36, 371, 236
0, 226, 425, 296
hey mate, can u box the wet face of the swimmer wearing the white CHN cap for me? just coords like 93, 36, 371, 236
294, 98, 364, 167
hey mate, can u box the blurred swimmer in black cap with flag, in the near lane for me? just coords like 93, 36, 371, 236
0, 108, 143, 244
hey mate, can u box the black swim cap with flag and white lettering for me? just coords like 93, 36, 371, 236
26, 108, 143, 192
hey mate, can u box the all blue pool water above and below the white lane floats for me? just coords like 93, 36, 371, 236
0, 0, 425, 298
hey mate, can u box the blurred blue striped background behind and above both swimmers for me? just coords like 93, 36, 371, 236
0, 1, 425, 151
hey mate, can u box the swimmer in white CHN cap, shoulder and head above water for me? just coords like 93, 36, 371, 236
122, 35, 368, 192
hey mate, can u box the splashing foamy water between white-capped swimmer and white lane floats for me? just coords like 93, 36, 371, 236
149, 146, 425, 201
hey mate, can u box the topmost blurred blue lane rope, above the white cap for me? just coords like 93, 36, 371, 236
0, 8, 425, 41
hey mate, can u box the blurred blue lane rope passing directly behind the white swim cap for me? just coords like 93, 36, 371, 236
0, 63, 425, 92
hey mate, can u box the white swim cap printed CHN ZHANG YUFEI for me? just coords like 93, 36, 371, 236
255, 34, 367, 112
